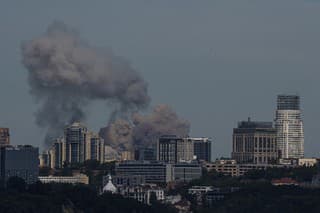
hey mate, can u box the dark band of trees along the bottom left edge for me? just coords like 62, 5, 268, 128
0, 178, 176, 213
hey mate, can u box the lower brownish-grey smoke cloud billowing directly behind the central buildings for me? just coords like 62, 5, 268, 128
100, 105, 190, 150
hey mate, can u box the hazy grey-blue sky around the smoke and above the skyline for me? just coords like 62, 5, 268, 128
0, 0, 320, 157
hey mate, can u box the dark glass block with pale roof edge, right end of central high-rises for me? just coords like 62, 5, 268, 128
190, 138, 212, 162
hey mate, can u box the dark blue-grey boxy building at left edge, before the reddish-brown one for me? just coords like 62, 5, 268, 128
0, 145, 39, 184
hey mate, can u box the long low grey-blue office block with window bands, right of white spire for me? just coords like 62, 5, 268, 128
115, 161, 172, 183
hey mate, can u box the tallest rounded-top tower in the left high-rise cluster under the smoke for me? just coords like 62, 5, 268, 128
64, 122, 88, 164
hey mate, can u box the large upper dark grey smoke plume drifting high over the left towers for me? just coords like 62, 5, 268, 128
21, 22, 150, 145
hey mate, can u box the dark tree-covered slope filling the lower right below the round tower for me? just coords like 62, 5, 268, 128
176, 167, 320, 213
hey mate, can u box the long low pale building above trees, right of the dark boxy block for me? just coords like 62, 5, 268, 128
39, 174, 89, 185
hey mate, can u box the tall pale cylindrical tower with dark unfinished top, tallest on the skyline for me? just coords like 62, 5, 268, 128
275, 95, 304, 158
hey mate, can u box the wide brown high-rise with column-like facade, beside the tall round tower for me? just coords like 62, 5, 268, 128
231, 119, 278, 164
